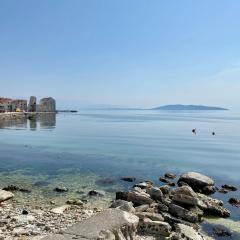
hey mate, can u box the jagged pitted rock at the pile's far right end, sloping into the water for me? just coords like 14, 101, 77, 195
198, 193, 230, 218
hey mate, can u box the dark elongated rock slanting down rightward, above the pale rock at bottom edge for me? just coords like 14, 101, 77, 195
169, 204, 200, 223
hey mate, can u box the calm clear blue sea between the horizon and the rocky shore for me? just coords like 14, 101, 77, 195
0, 110, 240, 219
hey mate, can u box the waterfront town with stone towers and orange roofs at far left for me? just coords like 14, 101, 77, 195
0, 96, 56, 113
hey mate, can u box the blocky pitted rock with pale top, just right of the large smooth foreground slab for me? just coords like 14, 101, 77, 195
138, 218, 171, 237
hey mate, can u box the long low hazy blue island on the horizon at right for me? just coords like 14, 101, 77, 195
151, 104, 228, 111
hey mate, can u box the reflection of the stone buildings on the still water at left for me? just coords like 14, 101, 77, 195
0, 113, 56, 131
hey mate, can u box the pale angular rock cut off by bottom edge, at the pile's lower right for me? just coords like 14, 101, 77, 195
172, 224, 204, 240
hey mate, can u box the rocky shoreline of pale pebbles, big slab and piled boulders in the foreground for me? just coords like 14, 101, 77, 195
0, 172, 239, 240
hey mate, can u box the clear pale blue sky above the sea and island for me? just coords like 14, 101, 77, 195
0, 0, 240, 109
